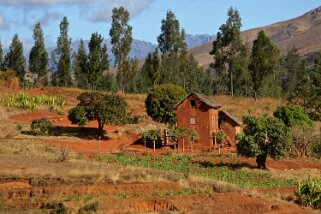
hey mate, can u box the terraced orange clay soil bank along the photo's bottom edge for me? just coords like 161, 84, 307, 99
0, 182, 313, 213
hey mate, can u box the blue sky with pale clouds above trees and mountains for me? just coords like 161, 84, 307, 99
0, 0, 321, 48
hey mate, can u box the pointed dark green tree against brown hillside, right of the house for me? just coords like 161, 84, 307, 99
249, 31, 279, 99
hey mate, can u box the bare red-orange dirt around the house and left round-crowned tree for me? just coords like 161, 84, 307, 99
10, 112, 321, 170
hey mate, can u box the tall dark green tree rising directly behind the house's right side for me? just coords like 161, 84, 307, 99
210, 7, 248, 96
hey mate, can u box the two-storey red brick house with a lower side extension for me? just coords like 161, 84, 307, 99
175, 93, 241, 149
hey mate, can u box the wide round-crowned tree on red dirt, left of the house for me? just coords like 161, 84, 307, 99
68, 92, 127, 134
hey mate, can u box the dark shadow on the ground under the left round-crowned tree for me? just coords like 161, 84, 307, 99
22, 126, 110, 140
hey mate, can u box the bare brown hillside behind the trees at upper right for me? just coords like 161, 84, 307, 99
190, 7, 321, 66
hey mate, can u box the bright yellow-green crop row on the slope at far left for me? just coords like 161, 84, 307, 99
0, 93, 65, 110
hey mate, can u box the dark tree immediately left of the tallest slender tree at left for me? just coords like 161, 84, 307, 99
86, 33, 109, 90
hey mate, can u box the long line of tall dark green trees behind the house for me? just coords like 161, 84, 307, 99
0, 7, 321, 119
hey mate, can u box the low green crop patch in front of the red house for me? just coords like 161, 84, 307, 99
101, 155, 296, 188
